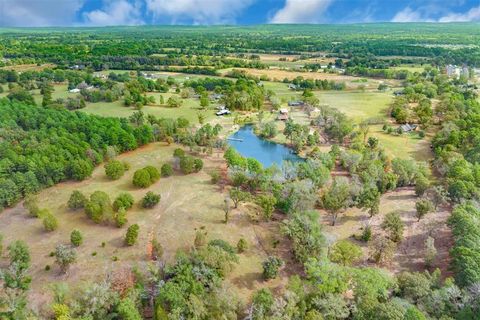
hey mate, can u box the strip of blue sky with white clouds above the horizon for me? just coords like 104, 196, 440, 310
0, 0, 480, 27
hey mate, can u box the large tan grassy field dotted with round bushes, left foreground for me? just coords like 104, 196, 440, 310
0, 143, 289, 312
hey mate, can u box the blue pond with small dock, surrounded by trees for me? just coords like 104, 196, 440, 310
228, 125, 303, 167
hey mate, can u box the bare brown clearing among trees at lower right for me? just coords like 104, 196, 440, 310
322, 188, 452, 277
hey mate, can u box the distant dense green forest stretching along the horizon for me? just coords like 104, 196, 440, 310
0, 23, 480, 70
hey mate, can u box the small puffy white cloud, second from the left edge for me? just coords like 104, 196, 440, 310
83, 0, 144, 26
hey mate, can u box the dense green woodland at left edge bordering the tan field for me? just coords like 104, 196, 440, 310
0, 99, 154, 208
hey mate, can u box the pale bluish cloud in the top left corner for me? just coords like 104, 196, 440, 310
0, 0, 84, 27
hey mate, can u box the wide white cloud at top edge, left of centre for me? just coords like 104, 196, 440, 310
146, 0, 255, 24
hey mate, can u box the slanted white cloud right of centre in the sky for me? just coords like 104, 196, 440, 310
270, 0, 333, 23
